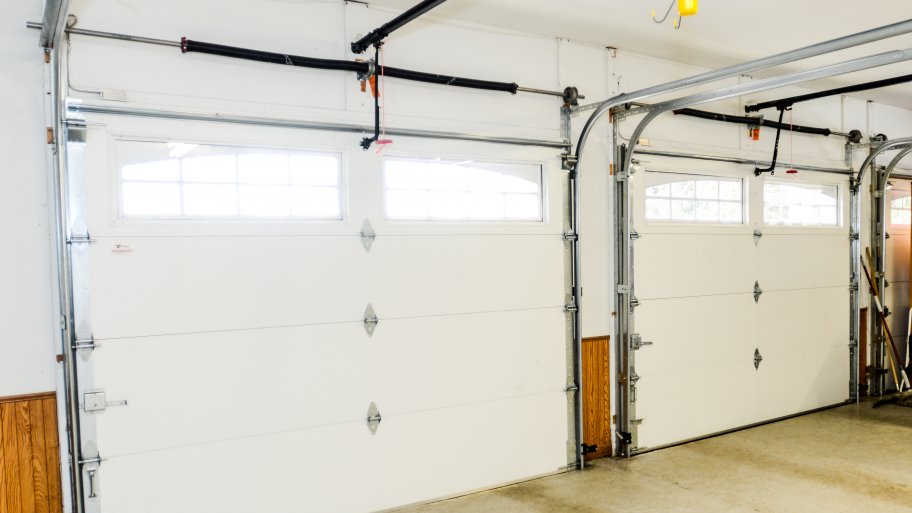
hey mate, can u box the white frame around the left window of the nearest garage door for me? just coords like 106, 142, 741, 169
109, 134, 350, 226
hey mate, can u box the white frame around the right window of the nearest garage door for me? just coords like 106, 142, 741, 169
379, 152, 550, 226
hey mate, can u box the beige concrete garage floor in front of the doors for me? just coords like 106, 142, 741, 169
399, 404, 912, 513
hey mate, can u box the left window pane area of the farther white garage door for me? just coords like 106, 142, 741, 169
645, 172, 744, 224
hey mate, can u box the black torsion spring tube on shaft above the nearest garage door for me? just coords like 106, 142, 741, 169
181, 37, 519, 94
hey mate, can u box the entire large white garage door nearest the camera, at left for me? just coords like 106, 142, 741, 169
71, 117, 570, 513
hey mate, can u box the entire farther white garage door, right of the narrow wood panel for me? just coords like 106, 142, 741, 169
632, 159, 850, 451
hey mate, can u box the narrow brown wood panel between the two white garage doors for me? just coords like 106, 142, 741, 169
583, 337, 611, 461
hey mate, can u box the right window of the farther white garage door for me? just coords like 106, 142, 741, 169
763, 181, 839, 226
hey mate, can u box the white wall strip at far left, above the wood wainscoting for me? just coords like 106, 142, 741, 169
0, 0, 57, 397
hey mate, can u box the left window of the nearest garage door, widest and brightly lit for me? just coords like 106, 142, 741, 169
116, 140, 342, 219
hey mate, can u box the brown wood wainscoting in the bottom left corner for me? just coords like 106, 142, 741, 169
0, 392, 63, 513
